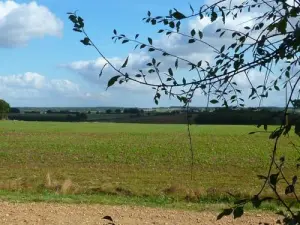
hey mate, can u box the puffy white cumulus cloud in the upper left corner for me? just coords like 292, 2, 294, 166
0, 1, 63, 48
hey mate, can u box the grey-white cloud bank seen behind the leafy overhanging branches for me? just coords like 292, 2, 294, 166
63, 0, 292, 105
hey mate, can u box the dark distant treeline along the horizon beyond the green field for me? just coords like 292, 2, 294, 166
8, 108, 300, 125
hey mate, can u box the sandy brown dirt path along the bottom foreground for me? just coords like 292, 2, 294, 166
0, 202, 279, 225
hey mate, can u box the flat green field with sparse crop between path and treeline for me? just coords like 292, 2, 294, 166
0, 121, 299, 209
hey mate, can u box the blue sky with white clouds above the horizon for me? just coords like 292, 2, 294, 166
0, 0, 296, 107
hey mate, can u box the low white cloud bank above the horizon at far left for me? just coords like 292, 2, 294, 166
0, 72, 109, 106
